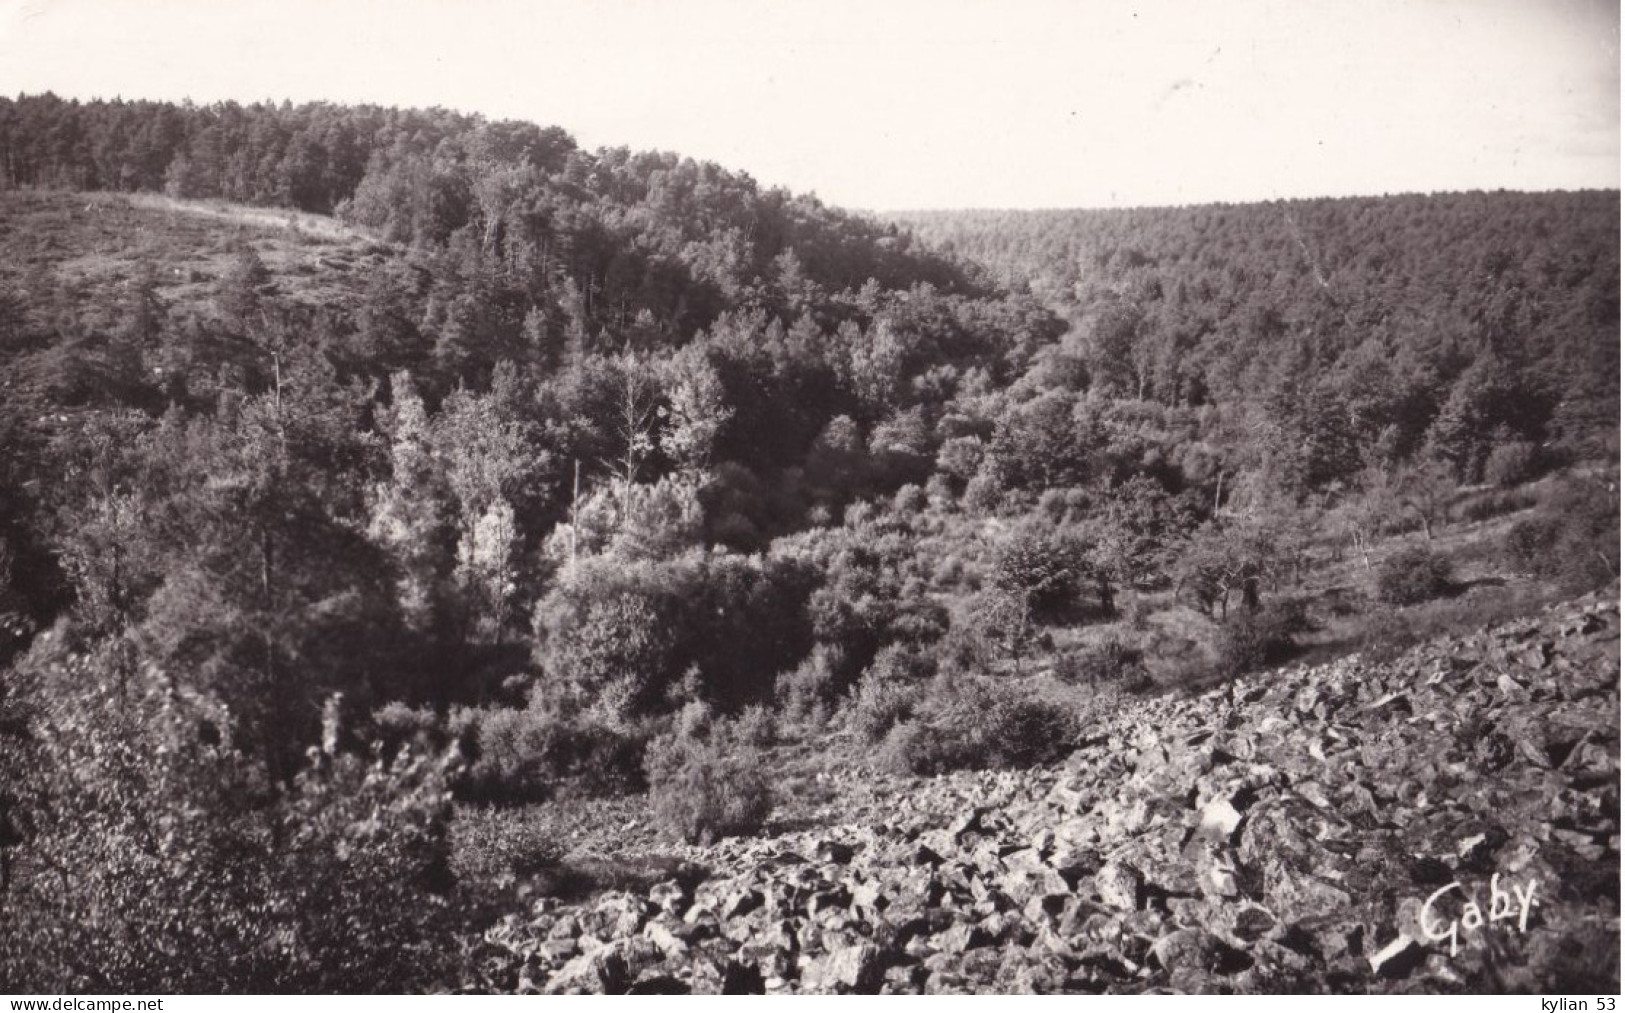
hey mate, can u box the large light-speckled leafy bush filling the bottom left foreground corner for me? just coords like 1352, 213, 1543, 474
0, 657, 466, 993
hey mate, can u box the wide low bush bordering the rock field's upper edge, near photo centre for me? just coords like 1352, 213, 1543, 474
881, 678, 1077, 774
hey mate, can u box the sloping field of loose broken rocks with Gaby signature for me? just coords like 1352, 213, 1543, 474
464, 597, 1620, 993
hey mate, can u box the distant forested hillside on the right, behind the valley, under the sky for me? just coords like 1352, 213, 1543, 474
891, 192, 1620, 465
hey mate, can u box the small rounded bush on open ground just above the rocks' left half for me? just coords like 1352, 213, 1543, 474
644, 724, 774, 844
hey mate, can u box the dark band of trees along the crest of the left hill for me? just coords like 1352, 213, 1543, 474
0, 94, 957, 326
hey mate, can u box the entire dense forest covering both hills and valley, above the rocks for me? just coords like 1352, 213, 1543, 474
0, 96, 1620, 992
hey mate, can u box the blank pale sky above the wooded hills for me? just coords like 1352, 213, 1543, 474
0, 0, 1620, 210
